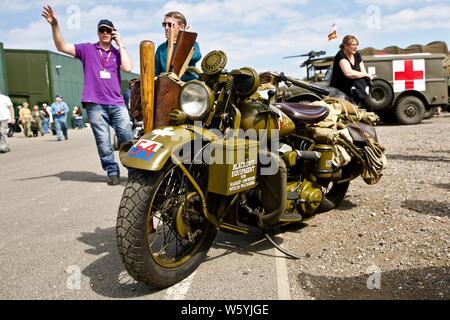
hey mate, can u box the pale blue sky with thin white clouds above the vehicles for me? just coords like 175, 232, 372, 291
0, 0, 450, 76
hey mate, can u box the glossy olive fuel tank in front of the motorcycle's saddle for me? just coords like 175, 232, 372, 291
239, 100, 295, 138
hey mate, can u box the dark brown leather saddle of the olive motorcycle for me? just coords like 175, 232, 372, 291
274, 102, 330, 123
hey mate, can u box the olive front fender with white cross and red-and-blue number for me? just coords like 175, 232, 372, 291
119, 125, 218, 171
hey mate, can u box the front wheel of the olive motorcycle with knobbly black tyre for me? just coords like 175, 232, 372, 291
116, 163, 217, 288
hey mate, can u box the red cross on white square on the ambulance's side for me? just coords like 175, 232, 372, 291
394, 60, 425, 91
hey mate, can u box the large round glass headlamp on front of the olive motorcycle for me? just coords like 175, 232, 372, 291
180, 80, 214, 120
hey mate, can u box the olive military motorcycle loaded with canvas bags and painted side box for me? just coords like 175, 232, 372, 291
116, 44, 385, 288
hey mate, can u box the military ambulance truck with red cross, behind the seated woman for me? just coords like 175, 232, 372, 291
285, 41, 450, 124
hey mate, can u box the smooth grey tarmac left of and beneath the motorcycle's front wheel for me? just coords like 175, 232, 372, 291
0, 128, 290, 300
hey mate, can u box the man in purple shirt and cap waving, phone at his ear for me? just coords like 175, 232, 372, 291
42, 6, 133, 185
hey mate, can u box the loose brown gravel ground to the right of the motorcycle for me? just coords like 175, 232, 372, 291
283, 113, 450, 299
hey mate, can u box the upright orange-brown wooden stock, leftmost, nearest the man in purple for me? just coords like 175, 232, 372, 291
140, 40, 155, 133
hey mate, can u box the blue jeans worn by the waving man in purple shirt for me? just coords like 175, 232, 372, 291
86, 104, 133, 177
